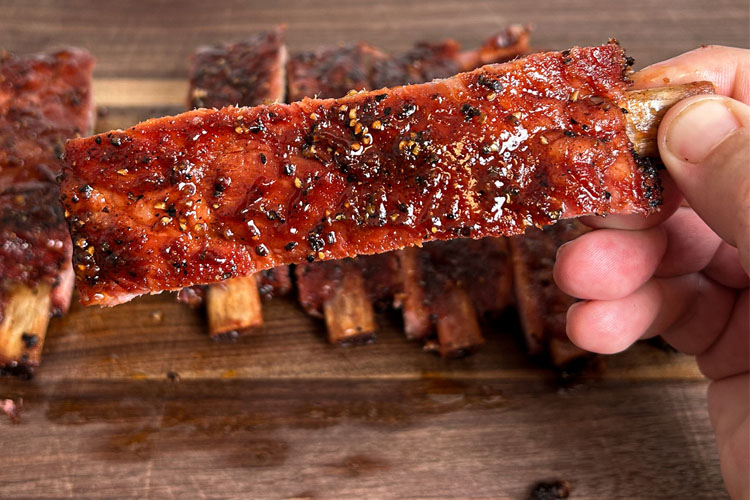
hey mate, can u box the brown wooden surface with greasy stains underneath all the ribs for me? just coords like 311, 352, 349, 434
0, 0, 750, 500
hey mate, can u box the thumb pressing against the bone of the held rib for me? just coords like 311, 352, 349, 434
659, 95, 750, 272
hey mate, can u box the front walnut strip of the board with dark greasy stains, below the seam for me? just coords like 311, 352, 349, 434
0, 375, 726, 500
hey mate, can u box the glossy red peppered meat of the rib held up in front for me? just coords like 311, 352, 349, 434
61, 42, 692, 305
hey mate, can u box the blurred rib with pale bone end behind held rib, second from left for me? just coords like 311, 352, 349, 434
178, 27, 292, 338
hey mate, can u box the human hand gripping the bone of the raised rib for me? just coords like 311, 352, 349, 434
555, 47, 750, 500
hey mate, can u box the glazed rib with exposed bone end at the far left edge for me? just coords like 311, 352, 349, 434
0, 49, 94, 376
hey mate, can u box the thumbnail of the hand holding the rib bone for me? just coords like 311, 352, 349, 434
666, 98, 740, 163
